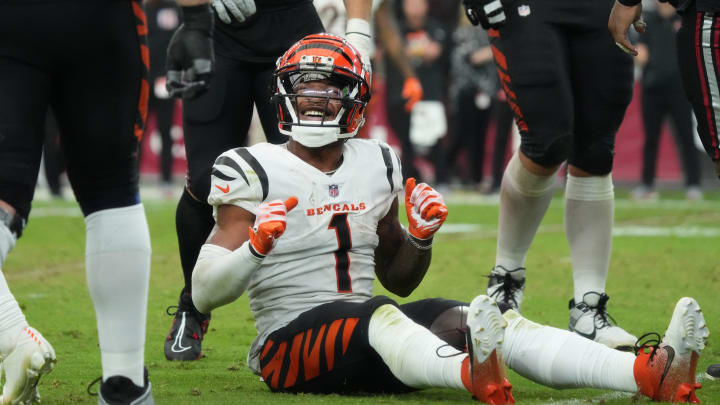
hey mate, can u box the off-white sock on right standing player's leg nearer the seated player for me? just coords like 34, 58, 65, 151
495, 152, 555, 270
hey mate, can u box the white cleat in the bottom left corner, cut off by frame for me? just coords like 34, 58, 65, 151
0, 326, 56, 405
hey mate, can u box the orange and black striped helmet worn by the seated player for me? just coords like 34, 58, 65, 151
272, 34, 372, 147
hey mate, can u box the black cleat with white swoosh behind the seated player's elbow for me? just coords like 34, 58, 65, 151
165, 291, 210, 361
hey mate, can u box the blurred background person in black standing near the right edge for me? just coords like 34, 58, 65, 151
632, 3, 703, 200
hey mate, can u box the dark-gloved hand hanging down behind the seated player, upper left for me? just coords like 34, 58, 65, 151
165, 4, 215, 98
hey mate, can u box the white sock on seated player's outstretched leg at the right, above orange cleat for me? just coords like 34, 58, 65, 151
502, 310, 637, 392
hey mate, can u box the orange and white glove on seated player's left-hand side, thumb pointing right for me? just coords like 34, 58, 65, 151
248, 196, 297, 255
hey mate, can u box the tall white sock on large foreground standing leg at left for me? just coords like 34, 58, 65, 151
85, 204, 151, 387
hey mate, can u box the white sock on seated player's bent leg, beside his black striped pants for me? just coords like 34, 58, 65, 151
368, 304, 467, 390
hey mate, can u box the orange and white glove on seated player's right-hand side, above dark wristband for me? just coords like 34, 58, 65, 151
405, 177, 448, 240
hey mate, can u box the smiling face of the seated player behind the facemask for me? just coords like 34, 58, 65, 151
294, 80, 342, 122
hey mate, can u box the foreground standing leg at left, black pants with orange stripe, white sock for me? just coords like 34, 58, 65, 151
51, 1, 152, 404
